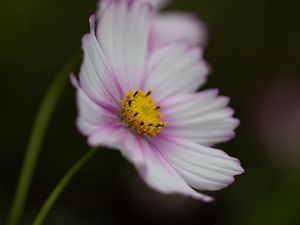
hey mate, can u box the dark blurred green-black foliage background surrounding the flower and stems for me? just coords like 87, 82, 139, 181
0, 0, 300, 225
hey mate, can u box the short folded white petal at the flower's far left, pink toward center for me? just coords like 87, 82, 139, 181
77, 88, 119, 135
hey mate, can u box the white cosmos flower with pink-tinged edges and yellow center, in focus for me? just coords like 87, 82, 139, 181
72, 0, 243, 201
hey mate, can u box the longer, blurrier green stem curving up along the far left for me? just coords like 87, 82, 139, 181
7, 51, 80, 225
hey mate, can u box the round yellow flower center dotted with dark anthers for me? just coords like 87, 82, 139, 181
121, 90, 167, 137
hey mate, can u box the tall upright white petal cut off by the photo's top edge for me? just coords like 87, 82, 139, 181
97, 0, 153, 92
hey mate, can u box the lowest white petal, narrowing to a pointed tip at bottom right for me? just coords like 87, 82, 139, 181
140, 140, 213, 202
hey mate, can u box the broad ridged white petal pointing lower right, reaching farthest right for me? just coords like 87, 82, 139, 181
157, 137, 244, 191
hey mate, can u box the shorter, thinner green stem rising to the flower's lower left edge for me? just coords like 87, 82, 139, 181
32, 149, 97, 225
